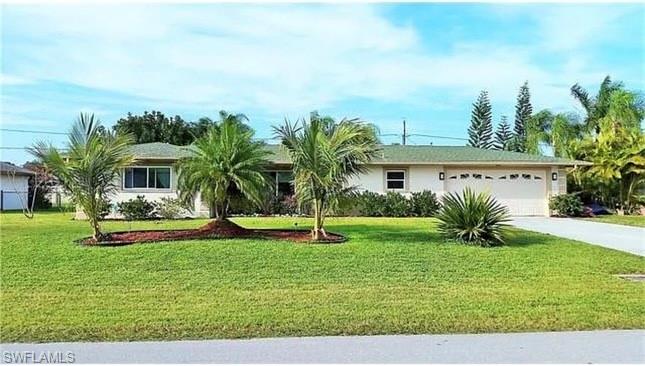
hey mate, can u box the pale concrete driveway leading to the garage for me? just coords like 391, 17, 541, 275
511, 217, 645, 256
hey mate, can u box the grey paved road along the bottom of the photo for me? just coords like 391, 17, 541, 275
1, 330, 645, 363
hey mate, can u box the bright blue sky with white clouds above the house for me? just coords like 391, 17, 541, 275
0, 4, 645, 163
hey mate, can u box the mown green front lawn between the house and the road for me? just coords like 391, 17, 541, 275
0, 212, 645, 342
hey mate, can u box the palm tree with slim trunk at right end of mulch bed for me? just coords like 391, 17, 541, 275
274, 112, 378, 240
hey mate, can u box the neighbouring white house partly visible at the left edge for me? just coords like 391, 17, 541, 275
0, 161, 35, 211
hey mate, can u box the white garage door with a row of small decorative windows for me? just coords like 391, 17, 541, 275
445, 168, 548, 216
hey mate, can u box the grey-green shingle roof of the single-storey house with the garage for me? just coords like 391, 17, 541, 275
132, 142, 590, 166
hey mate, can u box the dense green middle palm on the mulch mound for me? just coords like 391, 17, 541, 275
177, 116, 270, 221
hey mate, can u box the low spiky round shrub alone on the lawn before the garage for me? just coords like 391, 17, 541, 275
437, 188, 509, 246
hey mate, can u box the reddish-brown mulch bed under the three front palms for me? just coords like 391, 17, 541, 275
77, 220, 346, 246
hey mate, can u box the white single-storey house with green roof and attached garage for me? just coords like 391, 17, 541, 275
94, 143, 590, 216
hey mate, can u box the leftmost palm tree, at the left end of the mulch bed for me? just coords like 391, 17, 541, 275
29, 113, 134, 241
